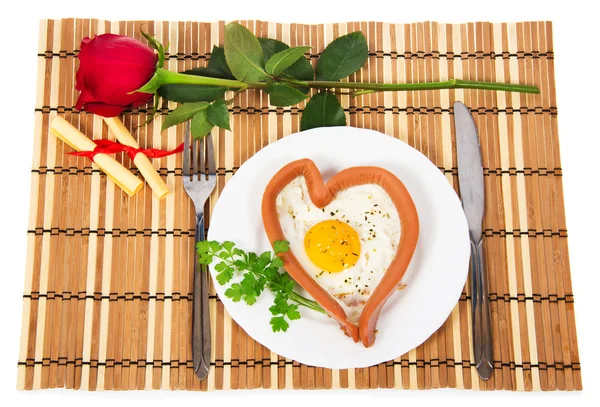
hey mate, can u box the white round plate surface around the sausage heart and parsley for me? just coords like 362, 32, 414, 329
207, 127, 470, 369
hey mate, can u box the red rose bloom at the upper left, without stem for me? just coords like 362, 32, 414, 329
75, 34, 157, 117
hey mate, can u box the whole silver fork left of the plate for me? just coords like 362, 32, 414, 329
183, 121, 217, 380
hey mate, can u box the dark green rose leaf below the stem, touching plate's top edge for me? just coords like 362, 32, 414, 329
300, 93, 346, 130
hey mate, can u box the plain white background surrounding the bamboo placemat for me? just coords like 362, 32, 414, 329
0, 0, 600, 406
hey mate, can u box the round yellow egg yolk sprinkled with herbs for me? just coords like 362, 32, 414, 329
304, 220, 360, 273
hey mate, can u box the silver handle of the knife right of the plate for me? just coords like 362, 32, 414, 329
470, 239, 494, 380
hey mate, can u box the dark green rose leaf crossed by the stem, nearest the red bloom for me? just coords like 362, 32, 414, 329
158, 68, 227, 103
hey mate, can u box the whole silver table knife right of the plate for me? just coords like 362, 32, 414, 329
454, 102, 494, 380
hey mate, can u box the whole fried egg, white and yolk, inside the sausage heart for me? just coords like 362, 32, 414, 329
277, 176, 401, 323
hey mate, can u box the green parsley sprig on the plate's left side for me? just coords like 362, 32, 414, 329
196, 240, 325, 332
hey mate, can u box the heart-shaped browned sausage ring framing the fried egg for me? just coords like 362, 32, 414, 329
262, 159, 419, 348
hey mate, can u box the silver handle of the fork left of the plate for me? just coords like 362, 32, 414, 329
192, 213, 211, 380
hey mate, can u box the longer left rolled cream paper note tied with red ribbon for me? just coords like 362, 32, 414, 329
50, 116, 144, 196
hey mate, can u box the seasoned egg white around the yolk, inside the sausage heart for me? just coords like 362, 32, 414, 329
277, 176, 401, 323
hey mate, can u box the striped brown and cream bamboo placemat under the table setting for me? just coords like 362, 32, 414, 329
18, 19, 581, 390
